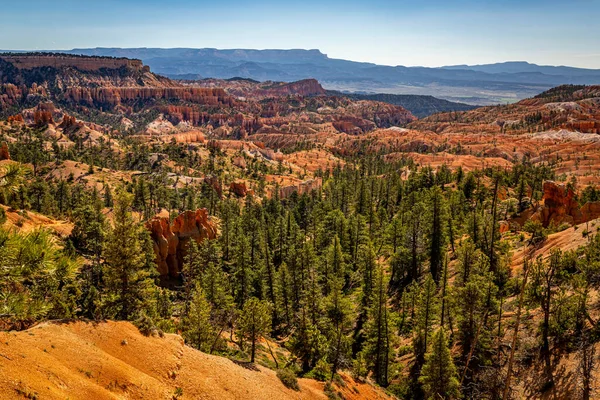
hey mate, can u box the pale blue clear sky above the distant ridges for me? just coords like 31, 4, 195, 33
0, 0, 600, 69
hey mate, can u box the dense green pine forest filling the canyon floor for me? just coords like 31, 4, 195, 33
0, 123, 600, 399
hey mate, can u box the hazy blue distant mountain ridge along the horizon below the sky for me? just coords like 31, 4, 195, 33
4, 48, 600, 105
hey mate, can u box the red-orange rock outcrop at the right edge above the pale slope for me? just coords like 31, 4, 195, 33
531, 181, 600, 227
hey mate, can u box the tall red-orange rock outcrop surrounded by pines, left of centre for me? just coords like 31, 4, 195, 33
146, 208, 217, 277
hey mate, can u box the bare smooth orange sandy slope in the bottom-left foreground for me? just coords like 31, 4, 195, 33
0, 321, 387, 400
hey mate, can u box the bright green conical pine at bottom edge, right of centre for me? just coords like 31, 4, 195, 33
419, 328, 460, 400
